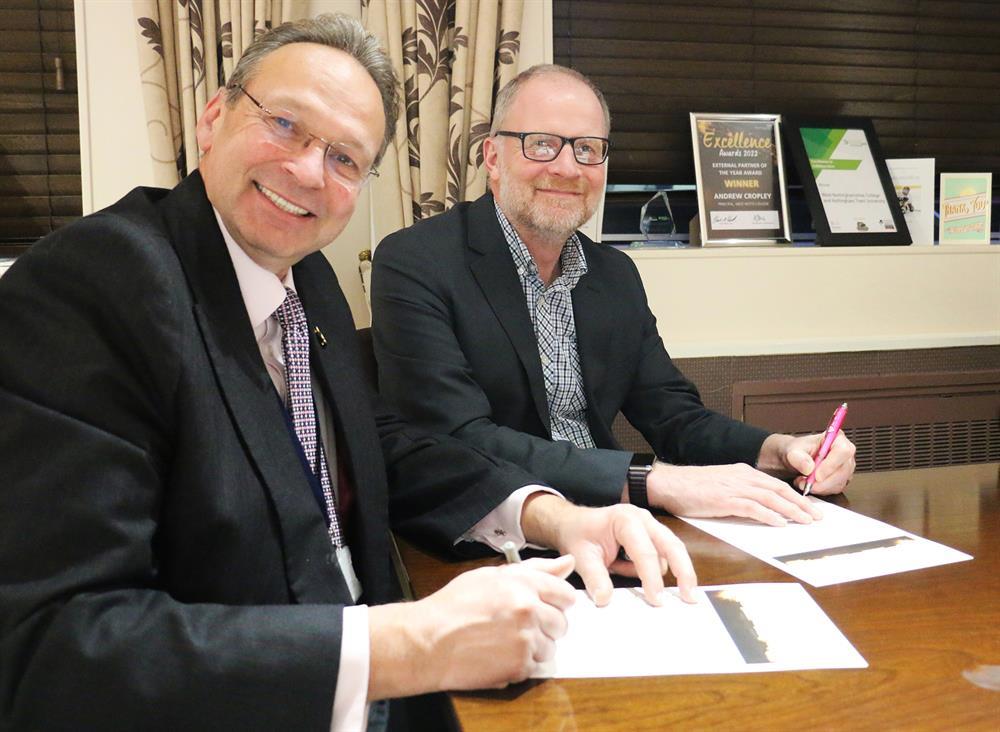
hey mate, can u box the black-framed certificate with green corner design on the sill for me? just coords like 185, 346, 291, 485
783, 117, 910, 246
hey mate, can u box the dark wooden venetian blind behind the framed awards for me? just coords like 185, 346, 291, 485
553, 0, 1000, 184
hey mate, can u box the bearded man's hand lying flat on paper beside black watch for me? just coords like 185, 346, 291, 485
646, 458, 823, 526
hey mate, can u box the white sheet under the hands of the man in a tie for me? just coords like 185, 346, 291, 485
535, 582, 868, 679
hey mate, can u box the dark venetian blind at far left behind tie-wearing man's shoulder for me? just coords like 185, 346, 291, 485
0, 0, 81, 248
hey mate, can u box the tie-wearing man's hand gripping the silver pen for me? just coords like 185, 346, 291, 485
368, 556, 575, 701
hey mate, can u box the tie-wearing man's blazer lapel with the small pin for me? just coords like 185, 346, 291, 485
294, 253, 391, 599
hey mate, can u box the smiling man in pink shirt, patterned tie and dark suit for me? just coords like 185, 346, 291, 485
0, 16, 696, 730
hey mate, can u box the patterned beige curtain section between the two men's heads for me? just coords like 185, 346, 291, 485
361, 0, 524, 243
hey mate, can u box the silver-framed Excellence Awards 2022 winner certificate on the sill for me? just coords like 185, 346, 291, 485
691, 112, 792, 246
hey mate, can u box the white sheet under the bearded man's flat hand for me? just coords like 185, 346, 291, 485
684, 498, 972, 587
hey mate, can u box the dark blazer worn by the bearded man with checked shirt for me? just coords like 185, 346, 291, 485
372, 193, 767, 505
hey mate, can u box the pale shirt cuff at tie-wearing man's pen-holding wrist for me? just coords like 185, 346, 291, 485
330, 605, 371, 732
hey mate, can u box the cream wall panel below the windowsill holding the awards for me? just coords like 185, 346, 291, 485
631, 245, 1000, 358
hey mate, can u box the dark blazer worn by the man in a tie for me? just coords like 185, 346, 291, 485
0, 173, 533, 730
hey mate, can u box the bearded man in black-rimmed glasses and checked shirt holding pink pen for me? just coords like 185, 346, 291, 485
372, 66, 854, 525
